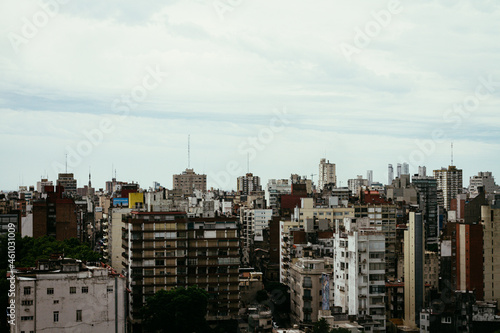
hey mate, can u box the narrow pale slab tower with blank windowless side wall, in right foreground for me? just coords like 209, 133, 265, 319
404, 212, 425, 327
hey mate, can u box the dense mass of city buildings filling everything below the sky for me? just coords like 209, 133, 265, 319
0, 158, 500, 332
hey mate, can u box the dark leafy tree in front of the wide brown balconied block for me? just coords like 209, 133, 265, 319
141, 286, 208, 333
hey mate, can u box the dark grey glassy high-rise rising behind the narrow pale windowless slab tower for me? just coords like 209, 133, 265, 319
412, 176, 439, 250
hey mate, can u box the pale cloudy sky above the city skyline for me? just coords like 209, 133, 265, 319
0, 0, 500, 190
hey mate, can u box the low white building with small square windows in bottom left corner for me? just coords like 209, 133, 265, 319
11, 259, 126, 333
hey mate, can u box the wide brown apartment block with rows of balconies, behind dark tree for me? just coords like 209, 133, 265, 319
123, 211, 240, 328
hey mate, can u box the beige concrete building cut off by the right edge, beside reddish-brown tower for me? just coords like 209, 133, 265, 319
481, 206, 500, 303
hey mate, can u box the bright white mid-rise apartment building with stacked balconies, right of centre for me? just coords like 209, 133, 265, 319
333, 218, 386, 332
